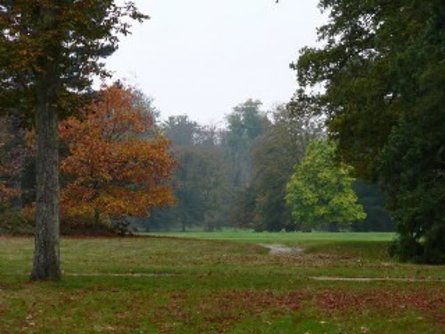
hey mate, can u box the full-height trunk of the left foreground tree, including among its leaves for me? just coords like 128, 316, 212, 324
31, 1, 61, 280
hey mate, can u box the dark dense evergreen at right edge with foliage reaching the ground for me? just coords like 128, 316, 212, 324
377, 1, 445, 264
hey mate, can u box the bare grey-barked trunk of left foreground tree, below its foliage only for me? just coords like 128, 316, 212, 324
31, 88, 61, 280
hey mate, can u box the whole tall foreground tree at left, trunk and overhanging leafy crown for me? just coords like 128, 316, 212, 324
0, 0, 146, 280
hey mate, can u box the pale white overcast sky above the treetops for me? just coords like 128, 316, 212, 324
107, 0, 324, 124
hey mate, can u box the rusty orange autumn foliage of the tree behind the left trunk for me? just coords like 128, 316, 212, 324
60, 85, 175, 218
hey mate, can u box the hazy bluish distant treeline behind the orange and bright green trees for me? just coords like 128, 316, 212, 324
142, 100, 394, 231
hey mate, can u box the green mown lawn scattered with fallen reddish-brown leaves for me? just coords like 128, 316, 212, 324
0, 232, 445, 333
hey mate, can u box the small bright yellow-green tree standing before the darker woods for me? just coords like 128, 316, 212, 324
286, 140, 366, 230
